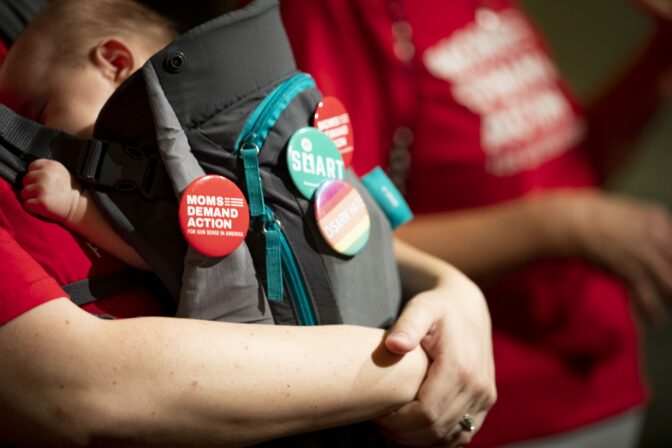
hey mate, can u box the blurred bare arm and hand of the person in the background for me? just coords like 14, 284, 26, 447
398, 190, 672, 322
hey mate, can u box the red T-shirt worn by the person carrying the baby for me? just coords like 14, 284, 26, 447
0, 180, 164, 325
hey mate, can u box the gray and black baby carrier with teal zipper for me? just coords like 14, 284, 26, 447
0, 0, 401, 327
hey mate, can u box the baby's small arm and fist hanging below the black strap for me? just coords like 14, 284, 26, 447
21, 159, 148, 270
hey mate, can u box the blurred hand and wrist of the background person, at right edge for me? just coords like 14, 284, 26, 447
536, 191, 672, 323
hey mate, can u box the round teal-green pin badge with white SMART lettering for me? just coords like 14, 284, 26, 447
287, 127, 345, 199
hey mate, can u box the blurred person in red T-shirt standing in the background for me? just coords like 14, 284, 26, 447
281, 0, 672, 446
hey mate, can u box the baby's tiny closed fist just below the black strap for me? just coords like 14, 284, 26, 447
21, 159, 82, 224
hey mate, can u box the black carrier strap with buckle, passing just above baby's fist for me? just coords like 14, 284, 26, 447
0, 105, 175, 200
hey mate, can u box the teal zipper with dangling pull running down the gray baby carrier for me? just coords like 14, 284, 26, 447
235, 73, 317, 325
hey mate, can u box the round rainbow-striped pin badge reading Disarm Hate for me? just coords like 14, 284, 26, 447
315, 179, 371, 255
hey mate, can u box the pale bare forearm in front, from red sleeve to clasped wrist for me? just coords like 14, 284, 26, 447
0, 299, 427, 446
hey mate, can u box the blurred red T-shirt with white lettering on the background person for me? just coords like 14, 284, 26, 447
281, 0, 645, 446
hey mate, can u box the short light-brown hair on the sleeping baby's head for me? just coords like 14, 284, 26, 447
24, 0, 177, 63
